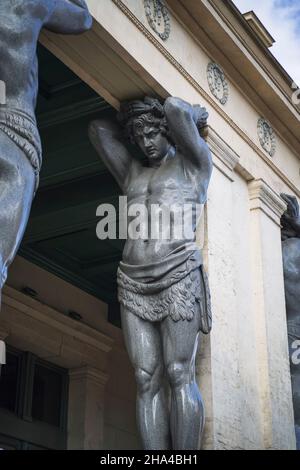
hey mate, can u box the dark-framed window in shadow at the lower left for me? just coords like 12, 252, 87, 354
0, 347, 68, 449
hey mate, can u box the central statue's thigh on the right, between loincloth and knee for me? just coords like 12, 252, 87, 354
161, 310, 200, 367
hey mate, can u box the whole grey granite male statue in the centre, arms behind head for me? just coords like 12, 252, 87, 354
90, 97, 212, 449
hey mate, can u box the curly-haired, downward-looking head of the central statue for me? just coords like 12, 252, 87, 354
118, 97, 173, 162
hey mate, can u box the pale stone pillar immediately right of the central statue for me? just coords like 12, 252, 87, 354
204, 128, 241, 450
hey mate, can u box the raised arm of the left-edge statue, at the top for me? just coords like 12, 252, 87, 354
44, 0, 93, 34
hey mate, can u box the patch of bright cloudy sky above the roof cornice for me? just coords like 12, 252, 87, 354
233, 0, 300, 87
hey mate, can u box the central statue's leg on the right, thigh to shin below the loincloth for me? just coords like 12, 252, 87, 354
161, 304, 204, 450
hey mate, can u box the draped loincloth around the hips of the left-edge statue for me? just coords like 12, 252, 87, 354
0, 108, 42, 191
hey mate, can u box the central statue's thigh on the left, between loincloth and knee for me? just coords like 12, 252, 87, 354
121, 306, 163, 374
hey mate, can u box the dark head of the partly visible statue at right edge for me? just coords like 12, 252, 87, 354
281, 194, 300, 240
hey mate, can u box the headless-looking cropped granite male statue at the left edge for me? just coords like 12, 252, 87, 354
0, 0, 92, 302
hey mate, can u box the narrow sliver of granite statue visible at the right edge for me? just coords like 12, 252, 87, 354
281, 194, 300, 450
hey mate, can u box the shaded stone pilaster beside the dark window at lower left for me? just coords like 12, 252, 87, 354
68, 366, 108, 450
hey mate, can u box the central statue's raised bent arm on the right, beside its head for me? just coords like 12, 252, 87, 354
164, 97, 212, 177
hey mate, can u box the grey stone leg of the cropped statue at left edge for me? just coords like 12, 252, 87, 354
0, 130, 35, 293
